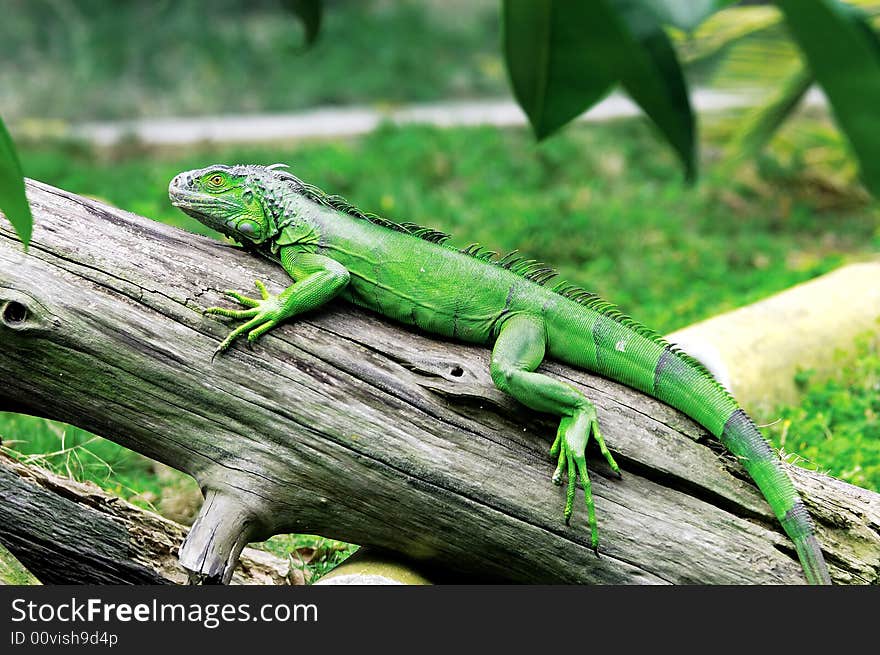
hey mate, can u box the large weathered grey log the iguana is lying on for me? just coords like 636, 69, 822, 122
0, 182, 880, 583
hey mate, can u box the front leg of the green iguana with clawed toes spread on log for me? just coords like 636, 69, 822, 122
204, 247, 349, 359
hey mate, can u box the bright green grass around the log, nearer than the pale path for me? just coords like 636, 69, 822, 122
0, 121, 880, 575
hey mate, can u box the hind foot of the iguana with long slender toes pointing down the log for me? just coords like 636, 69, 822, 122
550, 404, 622, 557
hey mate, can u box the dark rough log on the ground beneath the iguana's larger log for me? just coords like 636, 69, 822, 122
0, 453, 301, 584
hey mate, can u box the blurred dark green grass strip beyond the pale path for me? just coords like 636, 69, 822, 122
0, 0, 509, 122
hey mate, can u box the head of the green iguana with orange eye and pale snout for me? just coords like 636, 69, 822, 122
168, 164, 286, 243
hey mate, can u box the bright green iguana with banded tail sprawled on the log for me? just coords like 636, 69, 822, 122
169, 164, 830, 584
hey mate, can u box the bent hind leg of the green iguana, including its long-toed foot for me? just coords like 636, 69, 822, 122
490, 314, 620, 554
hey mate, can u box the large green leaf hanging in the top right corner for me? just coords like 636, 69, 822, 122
776, 0, 880, 194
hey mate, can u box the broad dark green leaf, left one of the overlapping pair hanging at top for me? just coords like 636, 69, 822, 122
502, 0, 615, 139
